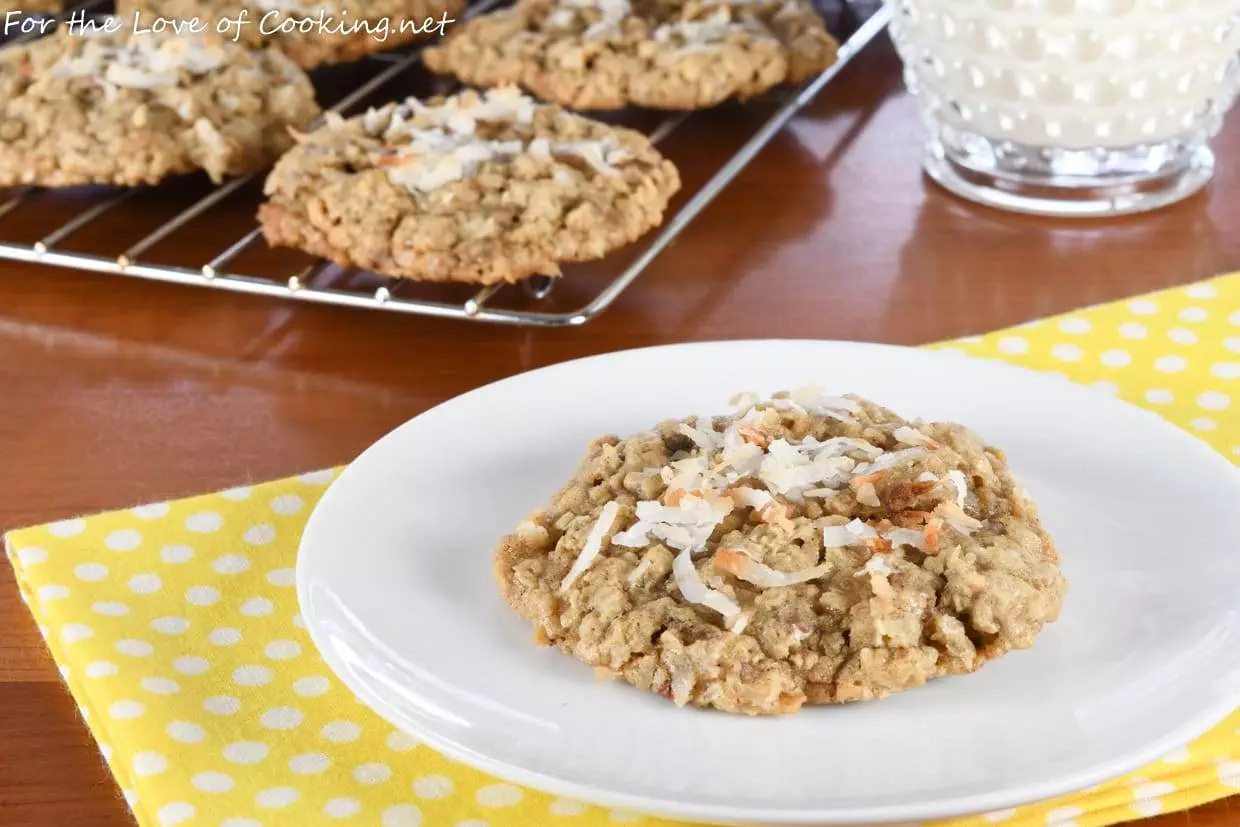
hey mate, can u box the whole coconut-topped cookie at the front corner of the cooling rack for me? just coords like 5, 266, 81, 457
258, 88, 680, 284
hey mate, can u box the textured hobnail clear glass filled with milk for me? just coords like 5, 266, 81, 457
887, 0, 1240, 216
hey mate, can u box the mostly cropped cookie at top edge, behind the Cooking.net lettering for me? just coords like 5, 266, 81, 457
117, 0, 466, 68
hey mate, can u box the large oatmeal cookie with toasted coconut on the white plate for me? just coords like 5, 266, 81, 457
495, 388, 1066, 714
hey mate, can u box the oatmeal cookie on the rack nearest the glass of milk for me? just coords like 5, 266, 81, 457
424, 0, 837, 109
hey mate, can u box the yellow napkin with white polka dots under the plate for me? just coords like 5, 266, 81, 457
6, 274, 1240, 827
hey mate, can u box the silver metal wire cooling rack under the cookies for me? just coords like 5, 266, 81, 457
0, 0, 890, 327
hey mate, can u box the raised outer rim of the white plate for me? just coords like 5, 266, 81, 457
295, 337, 1240, 826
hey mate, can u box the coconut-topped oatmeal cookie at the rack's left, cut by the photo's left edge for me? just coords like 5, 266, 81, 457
0, 32, 319, 187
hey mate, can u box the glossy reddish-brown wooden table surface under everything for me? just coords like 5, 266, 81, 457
0, 32, 1240, 827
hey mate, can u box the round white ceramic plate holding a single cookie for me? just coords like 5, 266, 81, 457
298, 341, 1240, 823
